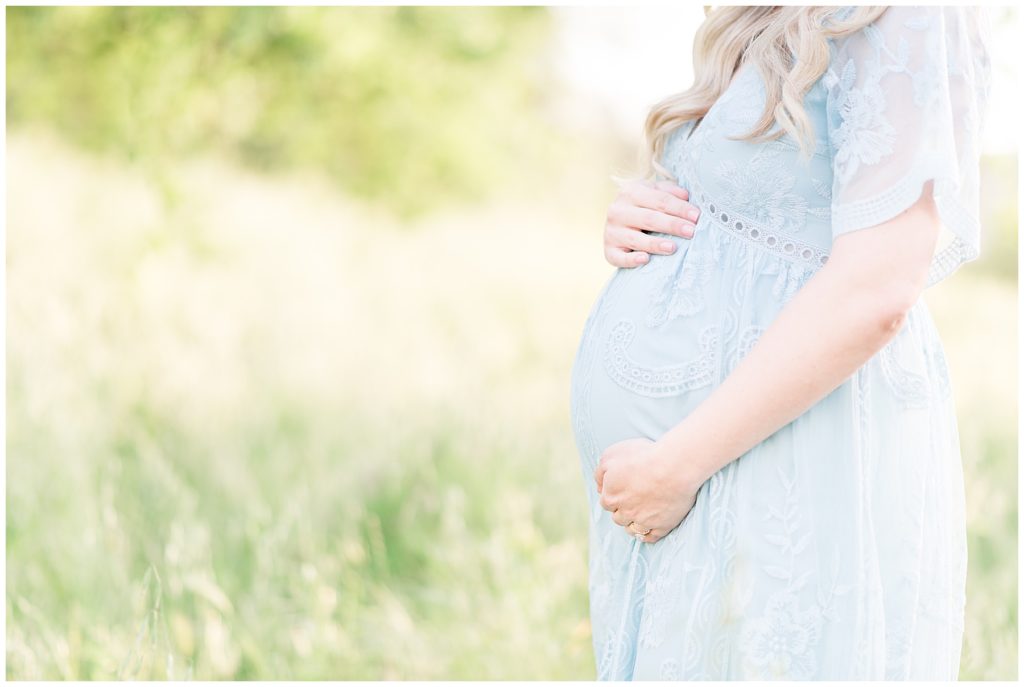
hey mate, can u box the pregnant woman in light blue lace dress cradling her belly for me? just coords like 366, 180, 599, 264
571, 6, 989, 680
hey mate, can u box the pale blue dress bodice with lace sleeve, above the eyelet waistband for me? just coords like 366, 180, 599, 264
663, 7, 991, 286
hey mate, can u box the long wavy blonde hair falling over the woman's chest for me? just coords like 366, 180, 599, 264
641, 6, 886, 179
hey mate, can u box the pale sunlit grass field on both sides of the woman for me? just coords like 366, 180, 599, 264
6, 134, 1018, 680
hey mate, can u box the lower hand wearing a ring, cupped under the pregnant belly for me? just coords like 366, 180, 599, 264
594, 438, 700, 544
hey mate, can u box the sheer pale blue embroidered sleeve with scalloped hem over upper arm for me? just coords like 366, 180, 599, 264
823, 6, 990, 286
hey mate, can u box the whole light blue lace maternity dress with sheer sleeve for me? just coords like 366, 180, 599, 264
570, 6, 989, 680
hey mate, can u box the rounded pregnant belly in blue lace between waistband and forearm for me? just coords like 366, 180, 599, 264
571, 229, 808, 473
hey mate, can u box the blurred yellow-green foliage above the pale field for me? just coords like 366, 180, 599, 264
7, 7, 549, 218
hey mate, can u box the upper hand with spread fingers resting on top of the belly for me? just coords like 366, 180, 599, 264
604, 180, 700, 267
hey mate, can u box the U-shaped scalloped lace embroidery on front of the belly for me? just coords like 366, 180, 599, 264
604, 319, 718, 398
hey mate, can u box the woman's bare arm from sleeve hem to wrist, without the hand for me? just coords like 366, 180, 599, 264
654, 182, 940, 487
